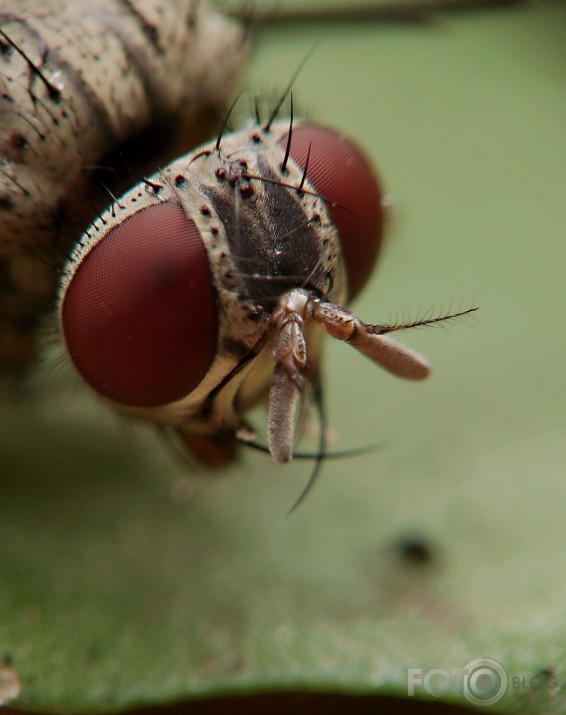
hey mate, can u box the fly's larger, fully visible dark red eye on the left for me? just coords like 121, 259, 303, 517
62, 202, 218, 407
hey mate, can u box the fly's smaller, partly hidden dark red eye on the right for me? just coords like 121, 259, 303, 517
280, 124, 383, 300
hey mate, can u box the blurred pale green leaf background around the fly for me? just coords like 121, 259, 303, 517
0, 0, 566, 713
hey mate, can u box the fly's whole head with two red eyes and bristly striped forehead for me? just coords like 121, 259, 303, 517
60, 121, 400, 470
